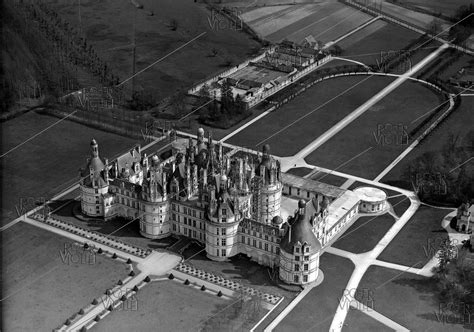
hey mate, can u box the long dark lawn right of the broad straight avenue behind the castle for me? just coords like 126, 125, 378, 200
306, 77, 440, 179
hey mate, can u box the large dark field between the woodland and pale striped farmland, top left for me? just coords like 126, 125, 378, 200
48, 0, 260, 99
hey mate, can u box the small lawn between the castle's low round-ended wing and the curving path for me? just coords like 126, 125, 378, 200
331, 214, 395, 254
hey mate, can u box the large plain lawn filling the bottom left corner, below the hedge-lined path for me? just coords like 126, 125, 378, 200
1, 222, 128, 331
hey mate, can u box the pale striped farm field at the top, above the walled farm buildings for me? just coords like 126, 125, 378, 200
242, 1, 371, 43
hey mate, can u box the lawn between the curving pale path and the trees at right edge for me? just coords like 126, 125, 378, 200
378, 205, 450, 268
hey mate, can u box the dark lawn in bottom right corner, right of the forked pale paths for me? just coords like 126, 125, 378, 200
359, 266, 473, 331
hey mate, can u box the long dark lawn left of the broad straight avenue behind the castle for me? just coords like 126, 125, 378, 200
228, 76, 393, 158
